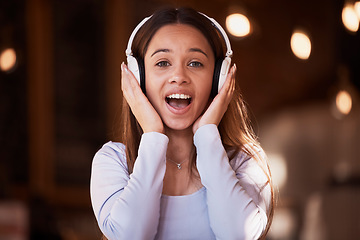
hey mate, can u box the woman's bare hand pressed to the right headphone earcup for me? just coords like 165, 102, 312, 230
193, 64, 236, 134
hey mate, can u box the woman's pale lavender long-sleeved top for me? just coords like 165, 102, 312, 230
90, 124, 271, 240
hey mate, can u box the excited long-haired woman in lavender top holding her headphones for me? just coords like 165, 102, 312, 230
91, 8, 273, 239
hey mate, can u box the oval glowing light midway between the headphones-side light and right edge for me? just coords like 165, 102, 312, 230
290, 32, 311, 60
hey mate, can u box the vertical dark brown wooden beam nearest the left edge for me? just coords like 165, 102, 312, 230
26, 0, 54, 199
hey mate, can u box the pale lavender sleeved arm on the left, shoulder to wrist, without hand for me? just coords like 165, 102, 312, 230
90, 132, 168, 240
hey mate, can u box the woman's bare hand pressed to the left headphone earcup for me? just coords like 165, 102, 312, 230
121, 63, 164, 133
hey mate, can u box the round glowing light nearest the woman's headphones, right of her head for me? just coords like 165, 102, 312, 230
226, 13, 250, 37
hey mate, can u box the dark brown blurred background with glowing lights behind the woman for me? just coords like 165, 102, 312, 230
0, 0, 360, 240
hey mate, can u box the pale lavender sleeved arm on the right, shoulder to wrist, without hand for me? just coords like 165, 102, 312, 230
194, 124, 271, 239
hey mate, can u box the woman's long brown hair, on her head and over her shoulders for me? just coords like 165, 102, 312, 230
120, 8, 274, 237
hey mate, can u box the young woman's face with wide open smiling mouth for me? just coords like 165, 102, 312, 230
144, 24, 215, 130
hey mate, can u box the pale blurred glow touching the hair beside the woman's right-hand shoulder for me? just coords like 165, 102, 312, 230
268, 154, 287, 189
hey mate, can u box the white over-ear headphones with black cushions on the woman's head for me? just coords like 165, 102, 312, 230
125, 10, 233, 97
